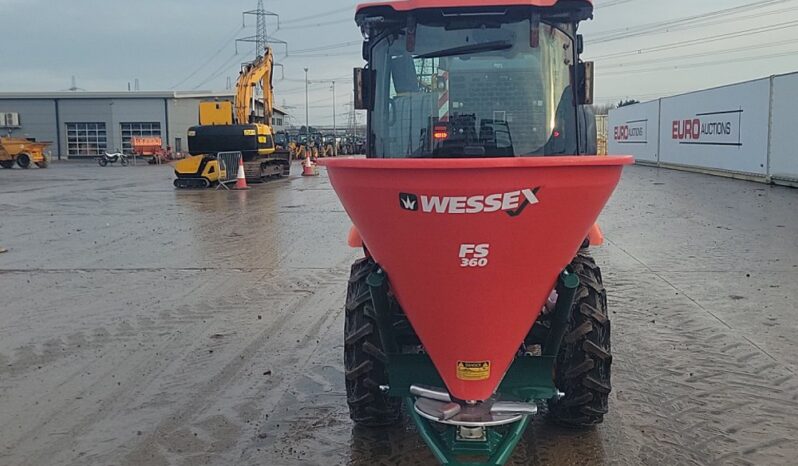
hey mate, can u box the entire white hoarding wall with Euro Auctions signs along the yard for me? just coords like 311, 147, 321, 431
608, 72, 798, 186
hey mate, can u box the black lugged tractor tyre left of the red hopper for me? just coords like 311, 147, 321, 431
344, 258, 402, 427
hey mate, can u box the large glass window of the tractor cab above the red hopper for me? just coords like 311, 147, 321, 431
370, 20, 577, 158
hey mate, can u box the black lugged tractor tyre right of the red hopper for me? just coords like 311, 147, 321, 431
549, 249, 612, 427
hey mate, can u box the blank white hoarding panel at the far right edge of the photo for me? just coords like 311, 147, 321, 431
770, 73, 798, 181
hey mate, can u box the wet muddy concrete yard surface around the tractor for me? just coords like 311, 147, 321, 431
0, 159, 798, 465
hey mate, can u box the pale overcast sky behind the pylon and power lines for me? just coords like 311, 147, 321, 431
0, 0, 798, 125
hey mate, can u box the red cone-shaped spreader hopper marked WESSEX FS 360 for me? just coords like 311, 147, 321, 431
320, 156, 632, 400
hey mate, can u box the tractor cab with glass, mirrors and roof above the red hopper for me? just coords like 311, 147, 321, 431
355, 0, 596, 158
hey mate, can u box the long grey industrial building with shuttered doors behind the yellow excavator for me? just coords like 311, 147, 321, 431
0, 91, 286, 159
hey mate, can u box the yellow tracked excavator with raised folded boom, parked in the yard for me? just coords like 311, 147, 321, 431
174, 47, 291, 188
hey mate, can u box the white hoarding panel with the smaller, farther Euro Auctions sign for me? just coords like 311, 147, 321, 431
607, 100, 659, 163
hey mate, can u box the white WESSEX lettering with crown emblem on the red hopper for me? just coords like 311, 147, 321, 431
399, 188, 540, 217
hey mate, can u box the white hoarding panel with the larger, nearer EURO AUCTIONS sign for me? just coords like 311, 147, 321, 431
659, 79, 770, 176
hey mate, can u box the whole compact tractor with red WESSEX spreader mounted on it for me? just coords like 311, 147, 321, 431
319, 0, 632, 465
